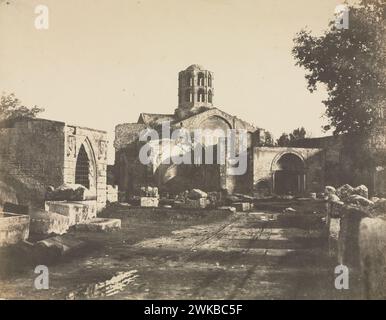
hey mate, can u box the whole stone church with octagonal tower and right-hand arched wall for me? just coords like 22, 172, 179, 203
114, 64, 324, 196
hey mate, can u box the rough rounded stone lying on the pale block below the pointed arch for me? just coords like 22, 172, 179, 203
46, 183, 95, 201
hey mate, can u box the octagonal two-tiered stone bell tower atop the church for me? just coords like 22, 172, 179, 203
176, 64, 214, 118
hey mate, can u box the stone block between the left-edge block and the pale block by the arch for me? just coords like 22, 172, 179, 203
30, 209, 70, 235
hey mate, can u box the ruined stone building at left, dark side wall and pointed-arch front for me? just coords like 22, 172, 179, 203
0, 119, 107, 209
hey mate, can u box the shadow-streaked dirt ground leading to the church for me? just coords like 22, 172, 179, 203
0, 204, 360, 299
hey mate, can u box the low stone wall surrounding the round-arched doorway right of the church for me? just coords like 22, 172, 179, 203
252, 147, 324, 192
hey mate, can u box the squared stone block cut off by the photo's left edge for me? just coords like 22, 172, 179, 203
0, 213, 30, 247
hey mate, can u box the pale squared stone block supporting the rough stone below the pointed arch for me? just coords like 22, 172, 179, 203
45, 201, 97, 226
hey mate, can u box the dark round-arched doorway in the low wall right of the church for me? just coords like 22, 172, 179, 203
272, 153, 306, 195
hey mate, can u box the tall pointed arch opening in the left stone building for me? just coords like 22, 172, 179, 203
75, 138, 97, 195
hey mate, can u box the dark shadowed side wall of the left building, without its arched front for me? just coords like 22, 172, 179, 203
0, 119, 65, 206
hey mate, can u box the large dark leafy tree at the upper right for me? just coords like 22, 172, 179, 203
292, 0, 386, 135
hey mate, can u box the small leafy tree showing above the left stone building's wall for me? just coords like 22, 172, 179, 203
0, 93, 44, 121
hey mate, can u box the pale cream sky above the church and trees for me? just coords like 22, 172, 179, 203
0, 0, 350, 162
